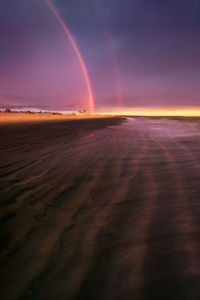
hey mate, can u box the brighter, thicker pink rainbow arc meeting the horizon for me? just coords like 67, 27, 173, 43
45, 0, 95, 112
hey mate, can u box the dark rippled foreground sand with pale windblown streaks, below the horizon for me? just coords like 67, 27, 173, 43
0, 118, 200, 300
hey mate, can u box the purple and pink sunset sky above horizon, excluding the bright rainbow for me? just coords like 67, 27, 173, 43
0, 0, 200, 111
